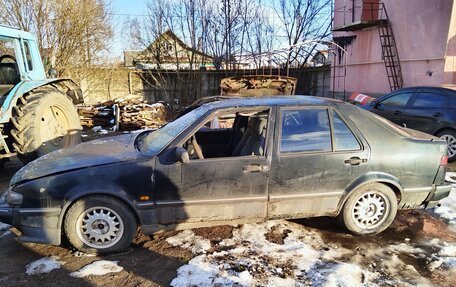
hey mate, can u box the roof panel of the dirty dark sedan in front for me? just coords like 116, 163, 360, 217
203, 95, 344, 109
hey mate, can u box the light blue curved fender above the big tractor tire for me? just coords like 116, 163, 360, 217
0, 79, 84, 124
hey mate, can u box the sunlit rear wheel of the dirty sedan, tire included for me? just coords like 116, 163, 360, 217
339, 183, 397, 235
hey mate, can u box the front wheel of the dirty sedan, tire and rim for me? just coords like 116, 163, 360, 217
64, 195, 137, 254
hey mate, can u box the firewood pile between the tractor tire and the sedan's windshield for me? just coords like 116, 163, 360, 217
78, 95, 174, 130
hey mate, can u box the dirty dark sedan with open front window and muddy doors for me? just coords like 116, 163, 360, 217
0, 96, 451, 253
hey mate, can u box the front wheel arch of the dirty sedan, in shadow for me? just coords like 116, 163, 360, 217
58, 182, 142, 233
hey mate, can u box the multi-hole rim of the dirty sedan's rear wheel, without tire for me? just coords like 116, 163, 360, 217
352, 191, 390, 229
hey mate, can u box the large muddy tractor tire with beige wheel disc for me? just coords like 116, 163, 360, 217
11, 87, 82, 163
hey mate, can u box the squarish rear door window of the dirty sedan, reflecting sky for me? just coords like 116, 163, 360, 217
280, 109, 332, 153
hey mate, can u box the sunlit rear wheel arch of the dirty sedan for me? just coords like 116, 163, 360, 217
337, 172, 404, 213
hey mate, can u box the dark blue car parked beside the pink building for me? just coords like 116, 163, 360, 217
363, 87, 456, 162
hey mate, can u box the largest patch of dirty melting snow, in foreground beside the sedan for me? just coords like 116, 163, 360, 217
167, 221, 442, 287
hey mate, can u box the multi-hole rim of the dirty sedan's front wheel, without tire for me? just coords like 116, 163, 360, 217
76, 206, 124, 249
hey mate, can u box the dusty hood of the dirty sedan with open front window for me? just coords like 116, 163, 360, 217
10, 133, 144, 186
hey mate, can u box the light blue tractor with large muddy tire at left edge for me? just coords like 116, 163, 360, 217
0, 25, 83, 166
